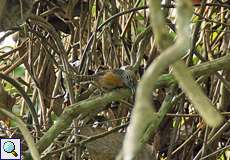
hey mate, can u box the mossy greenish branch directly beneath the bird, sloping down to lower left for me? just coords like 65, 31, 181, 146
37, 89, 131, 153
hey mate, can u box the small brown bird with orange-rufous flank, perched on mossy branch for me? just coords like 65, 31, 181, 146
74, 69, 137, 93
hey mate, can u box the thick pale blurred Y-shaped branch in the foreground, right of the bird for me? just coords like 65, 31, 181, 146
118, 0, 192, 160
